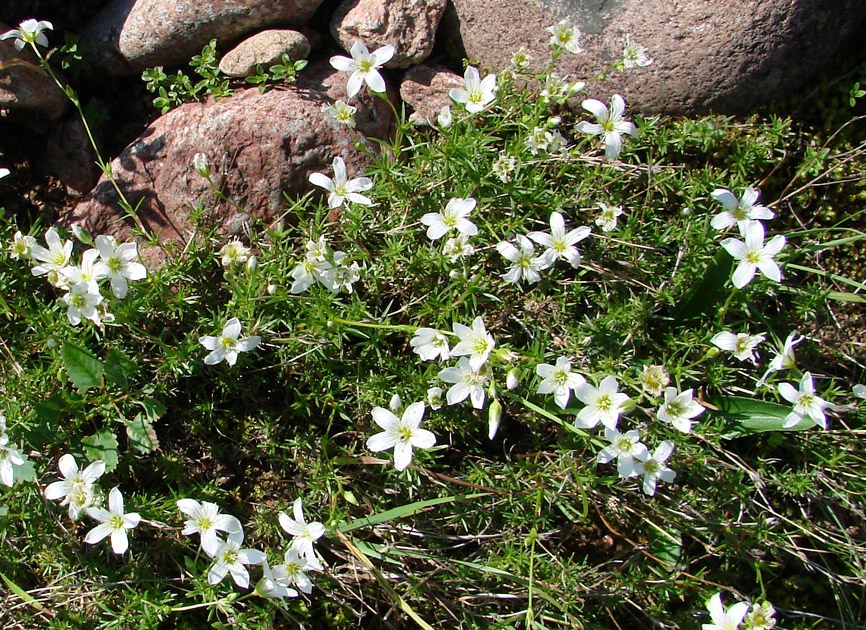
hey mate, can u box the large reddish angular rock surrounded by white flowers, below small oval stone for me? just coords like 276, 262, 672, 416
62, 70, 392, 263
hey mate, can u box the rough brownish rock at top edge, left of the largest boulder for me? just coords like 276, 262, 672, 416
331, 0, 447, 68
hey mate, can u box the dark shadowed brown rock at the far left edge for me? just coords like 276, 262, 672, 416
0, 23, 70, 123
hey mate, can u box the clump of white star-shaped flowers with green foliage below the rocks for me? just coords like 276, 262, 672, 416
0, 12, 866, 630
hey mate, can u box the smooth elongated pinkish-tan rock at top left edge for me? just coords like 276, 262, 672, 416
82, 0, 322, 76
